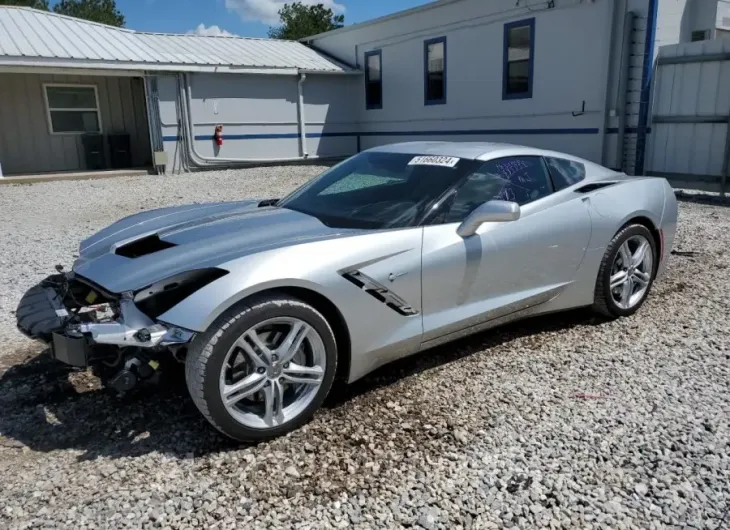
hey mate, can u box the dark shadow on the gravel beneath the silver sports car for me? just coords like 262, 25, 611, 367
0, 311, 601, 460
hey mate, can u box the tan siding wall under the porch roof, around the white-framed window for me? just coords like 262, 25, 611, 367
0, 73, 151, 175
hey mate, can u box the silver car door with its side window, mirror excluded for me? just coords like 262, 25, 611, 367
422, 156, 591, 346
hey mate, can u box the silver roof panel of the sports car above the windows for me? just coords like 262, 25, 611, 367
368, 142, 617, 177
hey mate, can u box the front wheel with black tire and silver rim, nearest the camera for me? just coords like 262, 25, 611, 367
185, 294, 337, 442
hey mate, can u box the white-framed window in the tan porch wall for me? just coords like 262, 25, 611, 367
44, 85, 101, 134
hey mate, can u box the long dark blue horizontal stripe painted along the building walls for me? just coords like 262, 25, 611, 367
162, 124, 610, 140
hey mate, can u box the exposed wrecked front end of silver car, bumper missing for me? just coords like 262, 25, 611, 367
16, 273, 194, 390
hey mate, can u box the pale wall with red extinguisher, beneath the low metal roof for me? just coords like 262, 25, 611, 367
158, 74, 359, 172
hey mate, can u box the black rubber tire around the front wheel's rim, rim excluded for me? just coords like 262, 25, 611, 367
203, 298, 337, 442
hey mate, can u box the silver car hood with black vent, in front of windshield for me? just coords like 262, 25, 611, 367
73, 201, 356, 293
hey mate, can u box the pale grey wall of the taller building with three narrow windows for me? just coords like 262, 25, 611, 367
313, 0, 660, 170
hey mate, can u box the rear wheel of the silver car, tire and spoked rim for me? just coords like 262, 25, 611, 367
593, 224, 656, 318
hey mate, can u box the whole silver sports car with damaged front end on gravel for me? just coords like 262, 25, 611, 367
17, 142, 677, 441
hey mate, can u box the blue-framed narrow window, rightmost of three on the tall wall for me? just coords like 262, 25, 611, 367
502, 18, 535, 99
